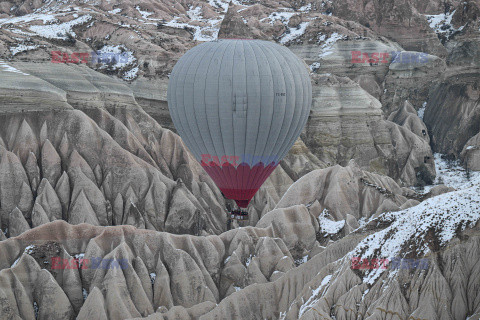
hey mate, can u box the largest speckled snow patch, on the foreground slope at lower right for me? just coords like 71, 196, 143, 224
346, 184, 480, 284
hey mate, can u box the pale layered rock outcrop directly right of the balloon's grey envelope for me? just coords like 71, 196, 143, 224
302, 74, 435, 186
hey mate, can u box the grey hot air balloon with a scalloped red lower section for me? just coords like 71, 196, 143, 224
167, 39, 312, 208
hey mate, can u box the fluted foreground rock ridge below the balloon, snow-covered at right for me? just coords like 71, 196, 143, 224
0, 182, 480, 320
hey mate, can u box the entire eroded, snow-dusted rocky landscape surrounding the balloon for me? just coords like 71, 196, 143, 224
0, 0, 480, 320
